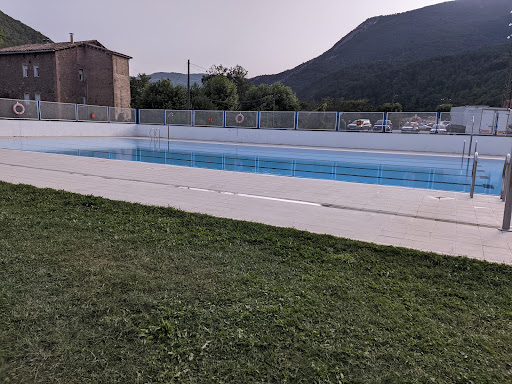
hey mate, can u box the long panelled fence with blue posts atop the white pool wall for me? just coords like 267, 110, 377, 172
0, 99, 512, 136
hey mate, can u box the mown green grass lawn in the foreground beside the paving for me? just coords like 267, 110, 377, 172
0, 183, 512, 384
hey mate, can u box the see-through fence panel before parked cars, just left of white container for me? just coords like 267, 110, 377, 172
387, 112, 438, 134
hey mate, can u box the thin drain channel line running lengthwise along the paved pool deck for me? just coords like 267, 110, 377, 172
0, 158, 499, 229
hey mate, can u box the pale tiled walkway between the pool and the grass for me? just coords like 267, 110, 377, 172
0, 149, 512, 265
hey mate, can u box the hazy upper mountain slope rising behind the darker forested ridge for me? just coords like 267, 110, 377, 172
252, 0, 512, 99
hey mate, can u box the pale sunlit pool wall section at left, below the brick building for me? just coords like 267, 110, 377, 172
0, 120, 137, 137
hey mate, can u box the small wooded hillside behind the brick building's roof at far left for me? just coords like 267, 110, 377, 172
0, 10, 51, 48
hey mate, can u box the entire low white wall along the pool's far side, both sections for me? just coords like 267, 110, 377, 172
0, 120, 512, 156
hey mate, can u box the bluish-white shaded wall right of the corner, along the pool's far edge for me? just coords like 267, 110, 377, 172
137, 125, 512, 156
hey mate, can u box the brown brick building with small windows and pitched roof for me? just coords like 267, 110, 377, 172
0, 37, 131, 107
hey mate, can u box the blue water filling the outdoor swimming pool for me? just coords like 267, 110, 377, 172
0, 138, 503, 195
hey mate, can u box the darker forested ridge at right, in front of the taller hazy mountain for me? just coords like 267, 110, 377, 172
310, 45, 511, 111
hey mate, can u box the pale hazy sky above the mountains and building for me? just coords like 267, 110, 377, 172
0, 0, 443, 77
